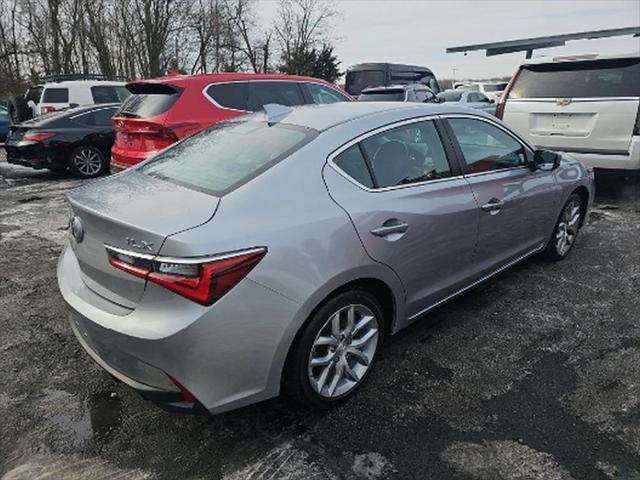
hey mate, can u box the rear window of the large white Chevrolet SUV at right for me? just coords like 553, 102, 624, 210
509, 58, 640, 98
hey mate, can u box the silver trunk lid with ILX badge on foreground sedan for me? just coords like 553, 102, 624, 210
67, 172, 219, 308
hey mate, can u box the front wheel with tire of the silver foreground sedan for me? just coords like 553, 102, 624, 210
543, 193, 585, 262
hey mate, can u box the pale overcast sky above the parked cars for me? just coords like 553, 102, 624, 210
256, 0, 640, 80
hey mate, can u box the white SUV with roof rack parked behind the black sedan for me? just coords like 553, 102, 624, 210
9, 74, 130, 124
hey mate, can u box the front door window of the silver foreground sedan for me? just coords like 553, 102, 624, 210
449, 119, 526, 173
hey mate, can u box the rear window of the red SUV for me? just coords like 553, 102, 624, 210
116, 83, 182, 118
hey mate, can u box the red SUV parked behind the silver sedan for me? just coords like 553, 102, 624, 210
111, 73, 353, 171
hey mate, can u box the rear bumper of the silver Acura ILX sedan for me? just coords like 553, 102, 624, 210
58, 248, 299, 413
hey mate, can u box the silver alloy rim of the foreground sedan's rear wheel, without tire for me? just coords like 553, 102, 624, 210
308, 304, 380, 398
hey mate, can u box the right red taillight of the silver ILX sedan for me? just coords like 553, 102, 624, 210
107, 247, 267, 305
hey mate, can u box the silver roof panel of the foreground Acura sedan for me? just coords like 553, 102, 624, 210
252, 102, 487, 131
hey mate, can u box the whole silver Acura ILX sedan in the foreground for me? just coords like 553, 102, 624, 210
58, 102, 593, 413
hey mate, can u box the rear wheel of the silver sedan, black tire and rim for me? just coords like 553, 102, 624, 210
283, 290, 384, 409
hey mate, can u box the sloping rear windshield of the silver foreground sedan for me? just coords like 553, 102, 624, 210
140, 122, 317, 195
